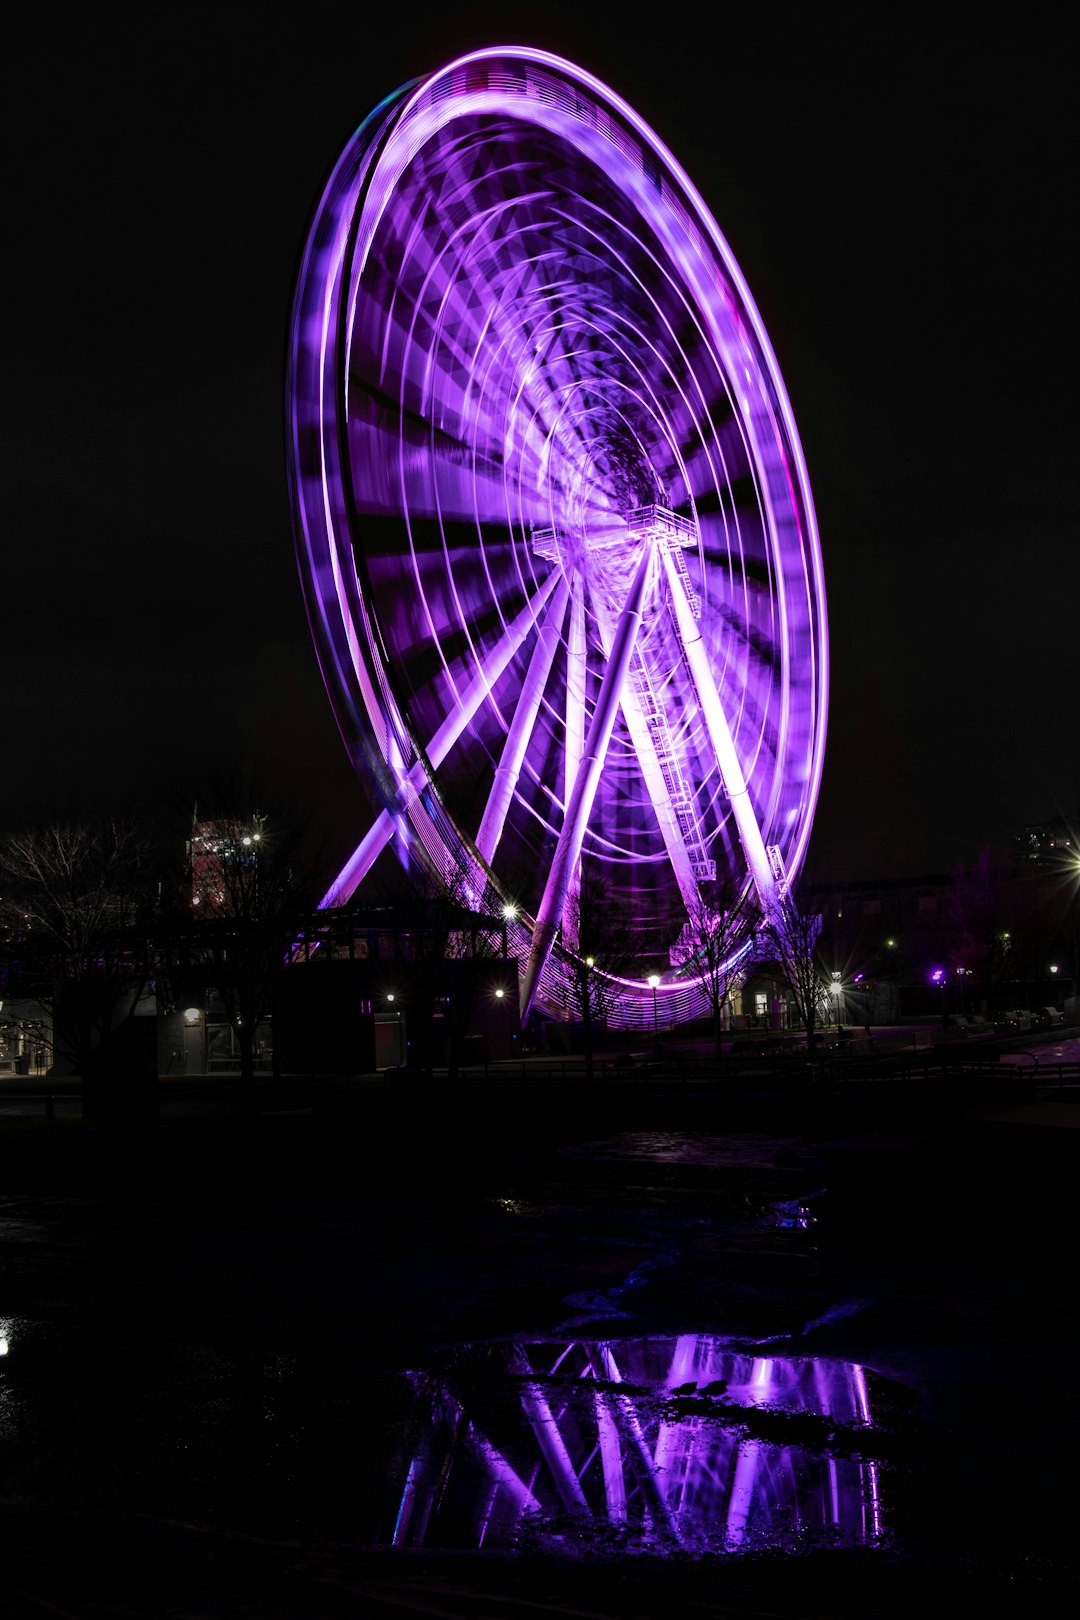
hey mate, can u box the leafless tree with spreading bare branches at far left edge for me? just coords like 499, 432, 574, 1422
0, 816, 159, 1119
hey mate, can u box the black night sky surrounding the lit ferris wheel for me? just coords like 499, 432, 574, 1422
2, 3, 1080, 878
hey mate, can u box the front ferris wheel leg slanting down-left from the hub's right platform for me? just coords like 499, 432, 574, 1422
521, 544, 656, 1017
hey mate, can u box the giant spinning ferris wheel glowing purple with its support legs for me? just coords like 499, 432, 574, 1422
287, 47, 827, 1024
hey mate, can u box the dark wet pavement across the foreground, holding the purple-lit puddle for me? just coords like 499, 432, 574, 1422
0, 1087, 1080, 1620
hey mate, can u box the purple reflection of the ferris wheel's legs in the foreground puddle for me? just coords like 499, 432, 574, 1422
392, 1335, 882, 1555
